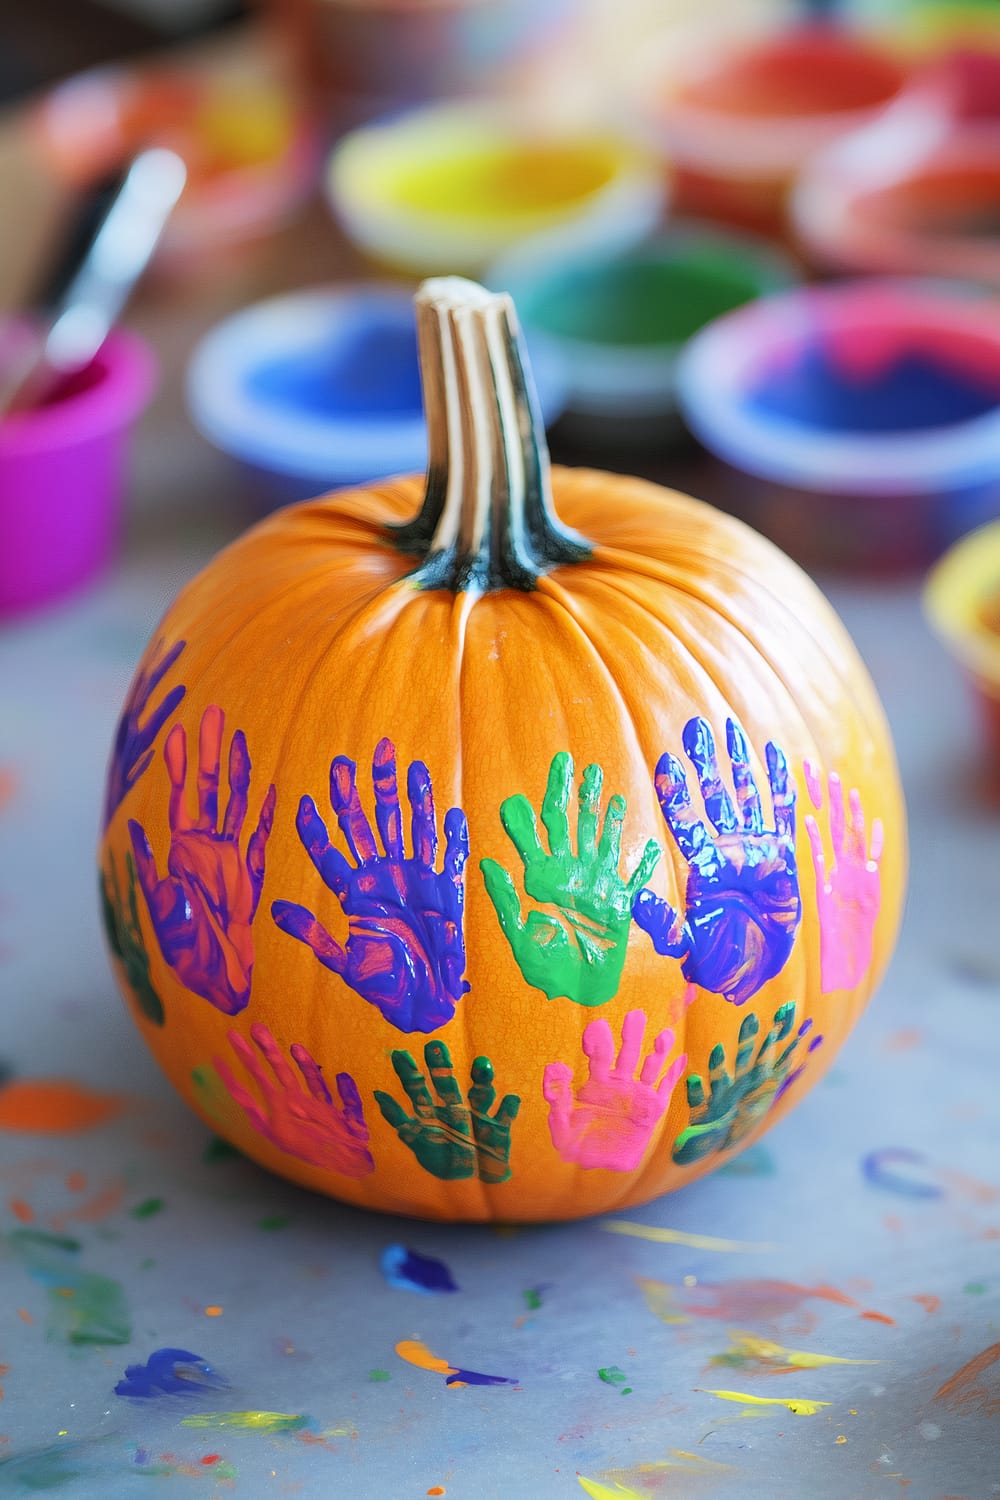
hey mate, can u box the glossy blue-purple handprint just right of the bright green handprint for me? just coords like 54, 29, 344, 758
633, 719, 802, 1005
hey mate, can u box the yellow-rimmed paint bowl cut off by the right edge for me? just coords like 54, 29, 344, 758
924, 522, 1000, 767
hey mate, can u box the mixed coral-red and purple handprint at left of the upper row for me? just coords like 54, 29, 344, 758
129, 705, 274, 1016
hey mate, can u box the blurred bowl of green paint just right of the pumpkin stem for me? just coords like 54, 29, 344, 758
489, 225, 798, 446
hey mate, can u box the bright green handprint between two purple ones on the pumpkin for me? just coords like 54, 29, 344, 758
480, 750, 660, 1005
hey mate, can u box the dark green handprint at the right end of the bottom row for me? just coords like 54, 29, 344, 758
673, 1001, 823, 1166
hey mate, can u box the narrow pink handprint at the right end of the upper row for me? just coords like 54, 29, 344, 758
804, 761, 885, 995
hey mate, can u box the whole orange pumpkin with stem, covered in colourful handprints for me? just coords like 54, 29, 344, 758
100, 279, 906, 1221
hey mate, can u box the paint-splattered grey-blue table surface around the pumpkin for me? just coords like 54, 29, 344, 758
0, 46, 1000, 1500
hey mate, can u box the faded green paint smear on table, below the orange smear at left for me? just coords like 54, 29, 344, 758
7, 1229, 132, 1344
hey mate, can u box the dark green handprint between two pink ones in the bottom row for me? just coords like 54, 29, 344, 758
375, 1041, 520, 1184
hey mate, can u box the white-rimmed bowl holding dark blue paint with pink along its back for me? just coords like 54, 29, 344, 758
678, 281, 1000, 572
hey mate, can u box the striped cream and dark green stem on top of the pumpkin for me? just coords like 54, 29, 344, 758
393, 276, 591, 593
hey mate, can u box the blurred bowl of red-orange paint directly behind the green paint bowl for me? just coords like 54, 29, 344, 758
640, 26, 904, 233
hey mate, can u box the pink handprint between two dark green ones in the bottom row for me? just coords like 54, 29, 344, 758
541, 1011, 688, 1172
